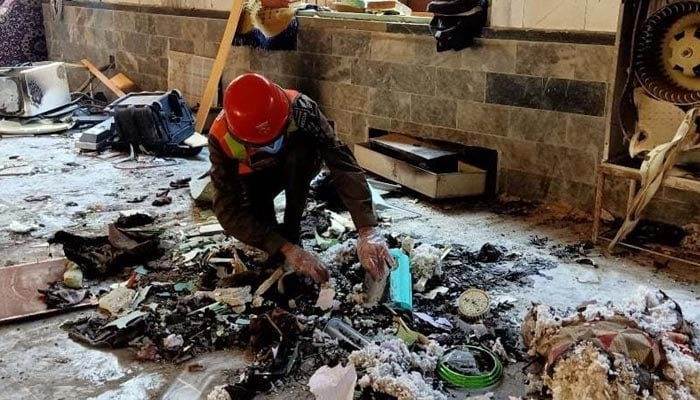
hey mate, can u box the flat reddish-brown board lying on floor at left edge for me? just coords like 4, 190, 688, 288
0, 258, 94, 323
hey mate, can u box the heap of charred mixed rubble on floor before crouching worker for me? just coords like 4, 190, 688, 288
41, 182, 568, 399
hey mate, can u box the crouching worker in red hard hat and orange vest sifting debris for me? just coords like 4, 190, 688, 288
209, 74, 393, 283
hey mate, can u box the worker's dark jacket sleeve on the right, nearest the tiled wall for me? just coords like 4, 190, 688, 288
292, 94, 377, 229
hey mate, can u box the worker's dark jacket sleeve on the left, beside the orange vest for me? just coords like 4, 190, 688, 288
209, 135, 287, 255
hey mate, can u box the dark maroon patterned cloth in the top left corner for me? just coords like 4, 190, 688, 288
0, 0, 48, 67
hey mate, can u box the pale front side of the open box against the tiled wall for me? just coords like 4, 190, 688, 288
355, 143, 486, 199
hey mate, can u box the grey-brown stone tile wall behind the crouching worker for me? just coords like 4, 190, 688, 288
46, 1, 697, 222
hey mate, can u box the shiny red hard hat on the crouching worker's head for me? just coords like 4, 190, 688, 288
224, 74, 289, 146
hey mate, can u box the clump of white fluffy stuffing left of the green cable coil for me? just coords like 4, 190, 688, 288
348, 339, 447, 400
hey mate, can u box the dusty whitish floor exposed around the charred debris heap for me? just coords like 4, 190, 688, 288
0, 137, 700, 399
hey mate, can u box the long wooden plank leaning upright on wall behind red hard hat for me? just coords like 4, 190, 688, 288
195, 0, 243, 133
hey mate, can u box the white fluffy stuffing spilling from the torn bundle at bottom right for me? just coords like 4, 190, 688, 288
522, 289, 700, 400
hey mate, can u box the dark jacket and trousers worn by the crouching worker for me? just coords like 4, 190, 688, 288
209, 94, 377, 255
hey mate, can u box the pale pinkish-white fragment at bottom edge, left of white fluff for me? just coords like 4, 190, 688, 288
309, 364, 357, 400
